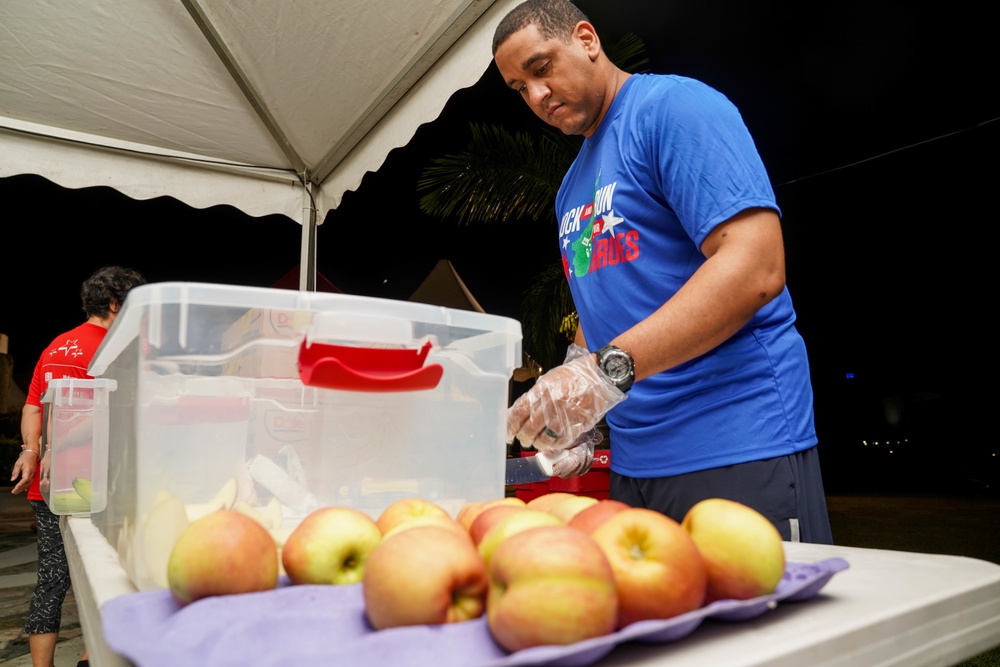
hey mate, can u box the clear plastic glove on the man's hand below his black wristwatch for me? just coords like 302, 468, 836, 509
507, 354, 625, 454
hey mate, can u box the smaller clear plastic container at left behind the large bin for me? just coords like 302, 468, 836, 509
39, 378, 117, 515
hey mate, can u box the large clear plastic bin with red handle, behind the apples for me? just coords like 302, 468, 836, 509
91, 283, 521, 590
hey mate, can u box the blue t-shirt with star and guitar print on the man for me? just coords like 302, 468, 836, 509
556, 75, 816, 477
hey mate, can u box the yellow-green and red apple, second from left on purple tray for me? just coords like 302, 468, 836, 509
281, 506, 382, 585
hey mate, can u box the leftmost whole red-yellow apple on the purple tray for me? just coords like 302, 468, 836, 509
167, 510, 278, 605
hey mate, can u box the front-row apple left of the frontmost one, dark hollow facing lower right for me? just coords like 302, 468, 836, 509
362, 525, 488, 630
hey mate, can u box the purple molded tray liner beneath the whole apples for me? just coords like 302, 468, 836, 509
101, 558, 848, 667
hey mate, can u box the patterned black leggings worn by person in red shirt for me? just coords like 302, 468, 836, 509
24, 500, 70, 635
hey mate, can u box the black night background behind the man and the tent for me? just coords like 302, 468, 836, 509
0, 0, 1000, 493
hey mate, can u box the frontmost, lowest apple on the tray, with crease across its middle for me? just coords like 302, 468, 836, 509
486, 528, 618, 651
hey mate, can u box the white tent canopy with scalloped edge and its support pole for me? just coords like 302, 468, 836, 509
0, 0, 517, 289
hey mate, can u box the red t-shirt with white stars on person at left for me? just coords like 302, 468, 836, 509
25, 322, 108, 500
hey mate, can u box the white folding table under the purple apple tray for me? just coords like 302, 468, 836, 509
62, 517, 1000, 667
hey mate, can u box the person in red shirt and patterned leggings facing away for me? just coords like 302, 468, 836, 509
10, 266, 146, 667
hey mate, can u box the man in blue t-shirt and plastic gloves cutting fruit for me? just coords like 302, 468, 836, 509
493, 0, 832, 543
